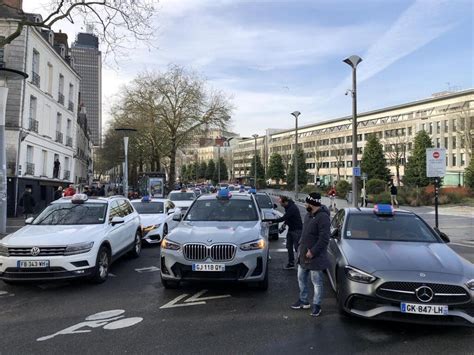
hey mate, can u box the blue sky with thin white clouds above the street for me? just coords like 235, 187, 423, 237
25, 0, 474, 136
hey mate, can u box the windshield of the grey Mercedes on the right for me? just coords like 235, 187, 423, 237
345, 212, 439, 242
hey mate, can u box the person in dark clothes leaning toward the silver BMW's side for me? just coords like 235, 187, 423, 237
272, 196, 303, 270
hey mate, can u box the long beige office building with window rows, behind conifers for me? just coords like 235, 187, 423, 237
264, 89, 474, 185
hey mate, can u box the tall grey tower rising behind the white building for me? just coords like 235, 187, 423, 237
71, 33, 102, 147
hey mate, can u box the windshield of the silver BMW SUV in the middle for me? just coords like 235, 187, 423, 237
185, 198, 258, 221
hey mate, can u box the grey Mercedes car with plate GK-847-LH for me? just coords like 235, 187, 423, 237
328, 205, 474, 326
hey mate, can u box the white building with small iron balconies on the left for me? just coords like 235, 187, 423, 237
0, 10, 80, 215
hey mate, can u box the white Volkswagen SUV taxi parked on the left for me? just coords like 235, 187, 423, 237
0, 194, 141, 284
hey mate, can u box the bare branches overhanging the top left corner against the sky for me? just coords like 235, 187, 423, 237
0, 0, 157, 54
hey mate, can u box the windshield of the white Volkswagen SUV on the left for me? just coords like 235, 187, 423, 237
32, 202, 107, 225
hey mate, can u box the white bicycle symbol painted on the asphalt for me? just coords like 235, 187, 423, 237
36, 309, 143, 341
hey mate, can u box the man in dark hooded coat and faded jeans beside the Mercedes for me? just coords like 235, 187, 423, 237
291, 192, 331, 317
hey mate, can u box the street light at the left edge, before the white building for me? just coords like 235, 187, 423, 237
0, 68, 28, 234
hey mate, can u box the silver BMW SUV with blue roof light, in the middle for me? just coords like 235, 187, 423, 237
160, 189, 269, 290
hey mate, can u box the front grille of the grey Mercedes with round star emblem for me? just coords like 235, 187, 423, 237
377, 282, 471, 304
